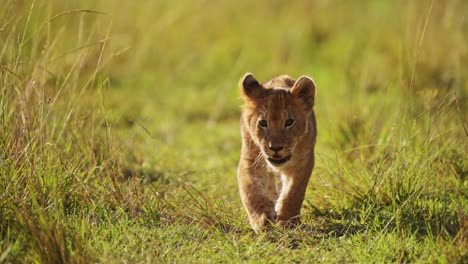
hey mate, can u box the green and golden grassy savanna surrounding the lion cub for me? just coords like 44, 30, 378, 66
0, 0, 468, 263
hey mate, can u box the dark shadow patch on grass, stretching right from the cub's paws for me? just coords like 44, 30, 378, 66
303, 197, 467, 241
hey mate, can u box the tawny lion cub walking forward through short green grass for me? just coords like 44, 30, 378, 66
237, 73, 317, 233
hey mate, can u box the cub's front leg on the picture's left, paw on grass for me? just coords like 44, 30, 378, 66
237, 161, 276, 233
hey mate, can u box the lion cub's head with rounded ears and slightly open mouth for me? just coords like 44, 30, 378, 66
239, 73, 315, 167
